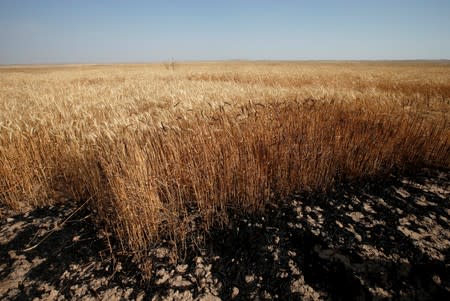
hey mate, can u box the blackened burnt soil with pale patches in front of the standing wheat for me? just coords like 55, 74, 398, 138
0, 169, 450, 301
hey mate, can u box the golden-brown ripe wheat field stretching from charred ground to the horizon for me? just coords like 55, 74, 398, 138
0, 62, 450, 272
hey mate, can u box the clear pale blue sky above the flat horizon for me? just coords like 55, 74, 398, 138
0, 0, 450, 64
